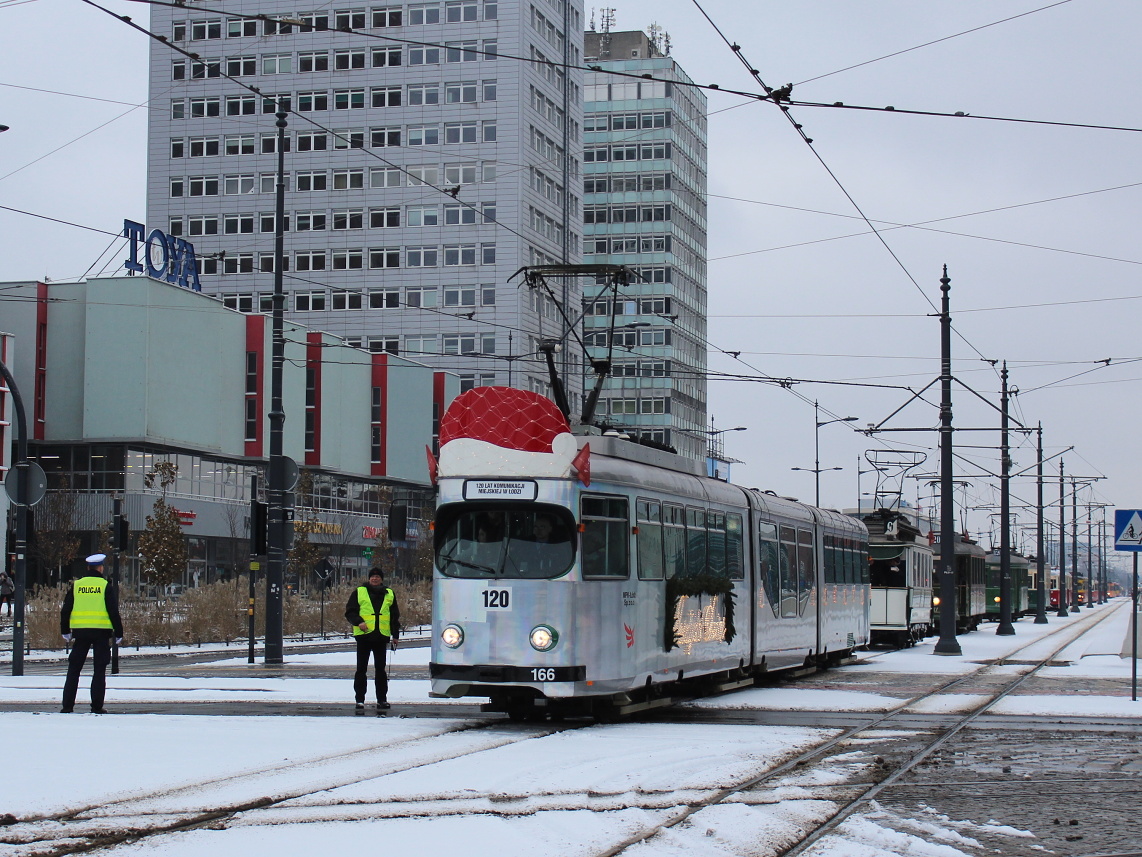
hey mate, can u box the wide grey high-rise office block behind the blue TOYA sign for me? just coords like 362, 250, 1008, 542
147, 0, 584, 402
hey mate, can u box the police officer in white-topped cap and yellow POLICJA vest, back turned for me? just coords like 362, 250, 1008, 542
59, 553, 123, 714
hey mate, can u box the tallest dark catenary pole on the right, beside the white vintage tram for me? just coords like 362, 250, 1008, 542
934, 265, 963, 655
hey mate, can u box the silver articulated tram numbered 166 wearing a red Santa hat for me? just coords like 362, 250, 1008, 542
429, 387, 869, 719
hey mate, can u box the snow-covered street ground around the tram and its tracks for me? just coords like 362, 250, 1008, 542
0, 601, 1142, 857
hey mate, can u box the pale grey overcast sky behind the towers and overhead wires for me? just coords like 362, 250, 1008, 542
0, 0, 1142, 557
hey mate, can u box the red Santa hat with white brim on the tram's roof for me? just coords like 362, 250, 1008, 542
429, 387, 590, 483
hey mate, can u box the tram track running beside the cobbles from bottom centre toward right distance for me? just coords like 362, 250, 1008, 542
595, 598, 1123, 857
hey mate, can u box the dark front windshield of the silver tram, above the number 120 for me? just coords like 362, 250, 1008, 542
436, 504, 574, 578
